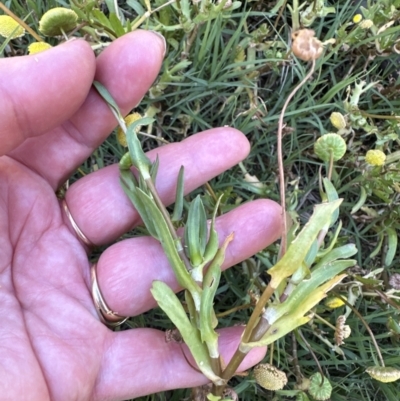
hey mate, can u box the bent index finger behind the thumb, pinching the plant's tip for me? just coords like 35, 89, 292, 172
12, 31, 165, 188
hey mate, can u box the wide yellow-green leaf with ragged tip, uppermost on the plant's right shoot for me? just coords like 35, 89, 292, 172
268, 199, 342, 288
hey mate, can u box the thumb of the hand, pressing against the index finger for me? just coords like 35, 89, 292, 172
0, 40, 95, 159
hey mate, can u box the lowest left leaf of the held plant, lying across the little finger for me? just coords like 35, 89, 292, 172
150, 281, 224, 385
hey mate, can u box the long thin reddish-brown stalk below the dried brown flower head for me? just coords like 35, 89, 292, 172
277, 60, 315, 258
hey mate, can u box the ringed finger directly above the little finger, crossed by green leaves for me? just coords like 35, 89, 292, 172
97, 200, 281, 316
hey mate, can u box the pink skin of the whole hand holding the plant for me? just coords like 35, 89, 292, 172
0, 31, 280, 401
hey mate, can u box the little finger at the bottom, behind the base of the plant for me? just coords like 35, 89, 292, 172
94, 327, 266, 400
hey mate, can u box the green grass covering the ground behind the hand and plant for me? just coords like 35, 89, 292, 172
3, 0, 400, 401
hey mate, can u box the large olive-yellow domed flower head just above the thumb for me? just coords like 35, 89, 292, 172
39, 7, 78, 36
